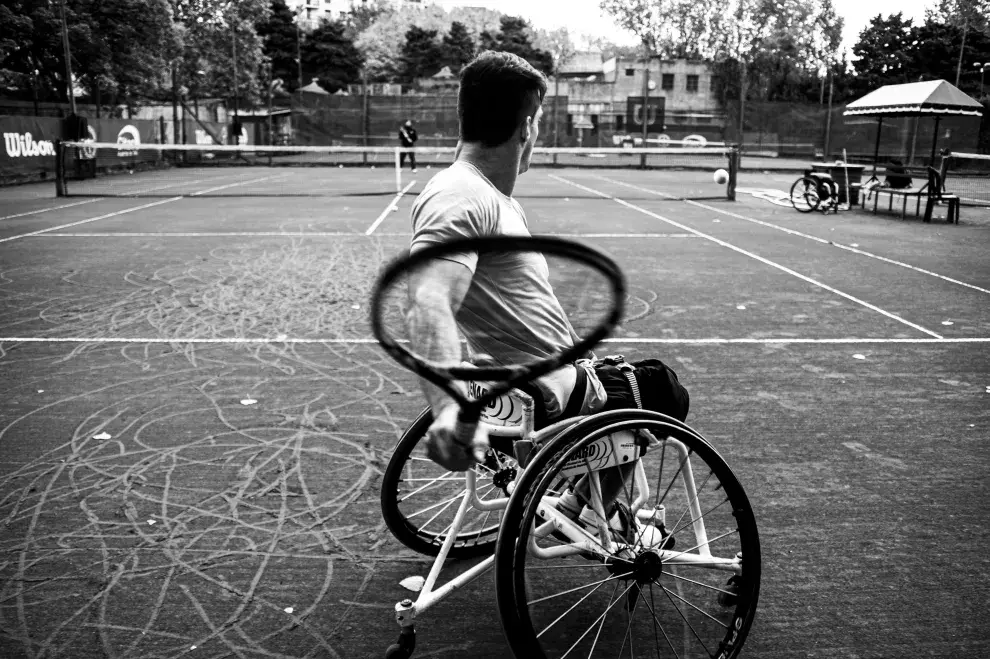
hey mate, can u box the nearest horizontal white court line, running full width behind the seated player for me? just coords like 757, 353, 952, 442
0, 336, 990, 345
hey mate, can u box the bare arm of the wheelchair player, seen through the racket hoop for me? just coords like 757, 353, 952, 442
406, 259, 473, 414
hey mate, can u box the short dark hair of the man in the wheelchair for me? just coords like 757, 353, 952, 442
457, 50, 547, 147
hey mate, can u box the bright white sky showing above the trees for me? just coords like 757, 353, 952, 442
435, 0, 935, 56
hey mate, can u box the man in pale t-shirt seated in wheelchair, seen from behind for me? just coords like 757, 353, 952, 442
406, 51, 689, 540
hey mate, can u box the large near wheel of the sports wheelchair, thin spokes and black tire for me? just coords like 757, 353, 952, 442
495, 410, 761, 659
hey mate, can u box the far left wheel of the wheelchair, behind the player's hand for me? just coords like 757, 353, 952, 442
381, 408, 516, 559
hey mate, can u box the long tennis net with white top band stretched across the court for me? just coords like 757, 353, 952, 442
56, 142, 738, 199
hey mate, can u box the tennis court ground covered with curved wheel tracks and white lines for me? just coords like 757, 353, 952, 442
0, 160, 990, 659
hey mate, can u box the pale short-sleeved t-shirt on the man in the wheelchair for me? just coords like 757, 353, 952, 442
411, 161, 576, 419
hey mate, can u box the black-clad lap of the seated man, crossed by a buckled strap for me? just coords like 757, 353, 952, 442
594, 355, 691, 421
